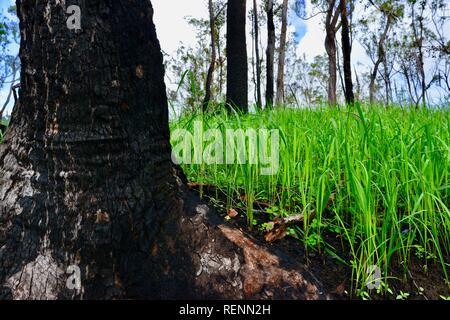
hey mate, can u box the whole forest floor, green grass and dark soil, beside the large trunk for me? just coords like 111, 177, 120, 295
171, 105, 450, 300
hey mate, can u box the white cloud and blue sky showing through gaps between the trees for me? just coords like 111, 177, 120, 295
0, 0, 450, 112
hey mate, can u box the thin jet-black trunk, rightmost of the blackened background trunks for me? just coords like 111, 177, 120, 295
341, 1, 355, 105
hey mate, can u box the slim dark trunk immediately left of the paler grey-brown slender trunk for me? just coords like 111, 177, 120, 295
266, 0, 275, 108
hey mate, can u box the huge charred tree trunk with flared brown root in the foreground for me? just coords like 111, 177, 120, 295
0, 0, 326, 299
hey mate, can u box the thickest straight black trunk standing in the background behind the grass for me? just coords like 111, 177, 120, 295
227, 0, 248, 112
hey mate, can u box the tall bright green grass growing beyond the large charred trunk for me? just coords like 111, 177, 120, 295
171, 106, 450, 295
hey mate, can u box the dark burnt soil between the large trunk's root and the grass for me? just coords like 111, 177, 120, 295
189, 183, 450, 300
